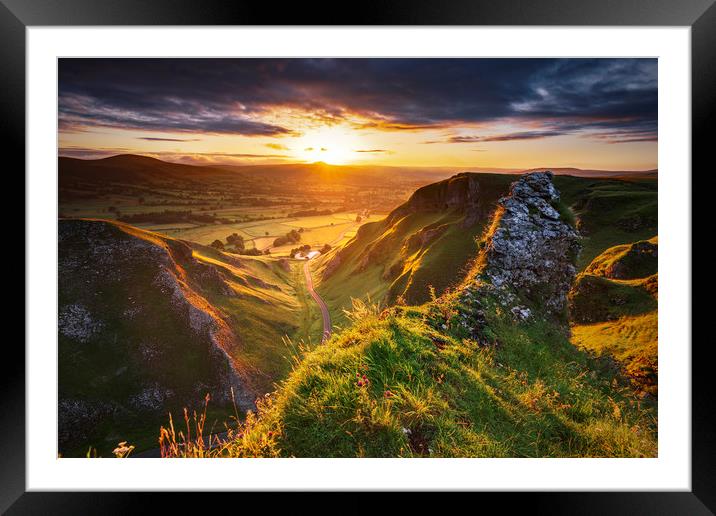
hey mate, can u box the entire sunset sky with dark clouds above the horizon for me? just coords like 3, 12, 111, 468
58, 58, 658, 170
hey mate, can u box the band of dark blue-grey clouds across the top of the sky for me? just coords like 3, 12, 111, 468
59, 59, 657, 141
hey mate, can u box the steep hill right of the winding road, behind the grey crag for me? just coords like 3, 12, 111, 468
317, 173, 515, 321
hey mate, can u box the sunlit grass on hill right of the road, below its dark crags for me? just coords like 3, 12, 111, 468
314, 174, 516, 325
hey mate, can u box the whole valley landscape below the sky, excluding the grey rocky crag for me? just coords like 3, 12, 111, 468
59, 156, 657, 456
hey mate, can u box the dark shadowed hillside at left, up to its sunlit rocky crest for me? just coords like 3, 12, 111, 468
58, 220, 255, 449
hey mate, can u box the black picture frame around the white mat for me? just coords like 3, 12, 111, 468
0, 0, 716, 515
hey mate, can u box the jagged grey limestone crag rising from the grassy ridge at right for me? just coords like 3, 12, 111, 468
482, 172, 581, 318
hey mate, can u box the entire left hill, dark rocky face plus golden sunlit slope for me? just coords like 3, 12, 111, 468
58, 220, 320, 455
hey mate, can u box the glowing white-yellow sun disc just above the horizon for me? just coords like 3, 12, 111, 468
291, 126, 359, 165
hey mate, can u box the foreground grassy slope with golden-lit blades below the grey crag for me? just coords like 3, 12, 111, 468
206, 296, 656, 457
